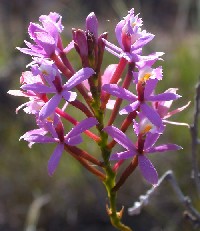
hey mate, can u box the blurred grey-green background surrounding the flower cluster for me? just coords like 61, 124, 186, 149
0, 0, 200, 231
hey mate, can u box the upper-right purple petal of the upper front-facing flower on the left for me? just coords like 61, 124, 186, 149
64, 67, 95, 90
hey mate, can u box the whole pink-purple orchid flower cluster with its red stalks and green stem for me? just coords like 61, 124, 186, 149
9, 9, 187, 230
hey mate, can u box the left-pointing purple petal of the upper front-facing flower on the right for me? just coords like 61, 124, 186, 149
102, 84, 137, 102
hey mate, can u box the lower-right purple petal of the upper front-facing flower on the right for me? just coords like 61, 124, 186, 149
140, 103, 162, 127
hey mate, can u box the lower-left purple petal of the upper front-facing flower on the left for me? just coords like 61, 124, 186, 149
39, 94, 62, 120
